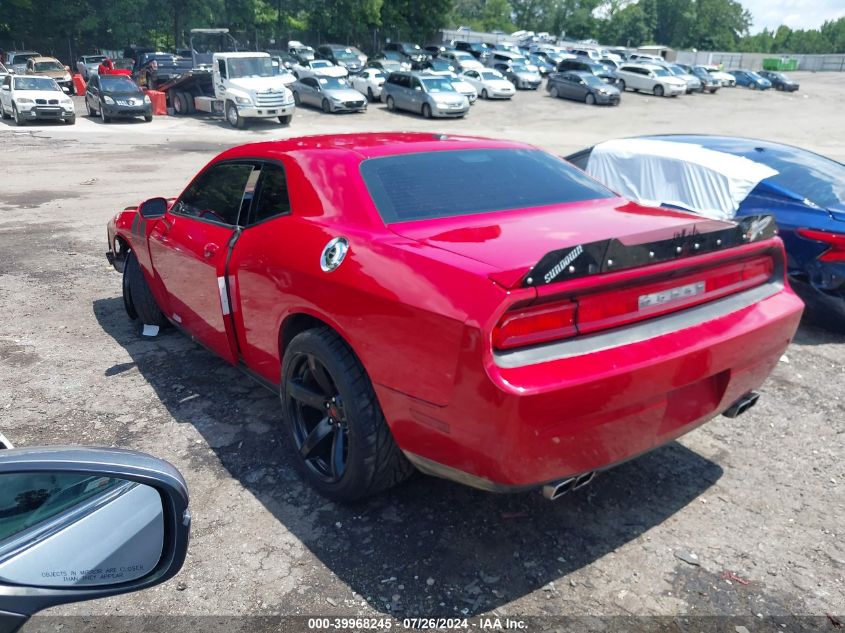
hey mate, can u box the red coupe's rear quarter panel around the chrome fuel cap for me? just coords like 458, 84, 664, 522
230, 150, 505, 405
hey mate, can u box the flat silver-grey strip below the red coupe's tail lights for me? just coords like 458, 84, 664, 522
493, 279, 783, 369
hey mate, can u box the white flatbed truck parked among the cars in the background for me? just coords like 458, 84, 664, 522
159, 52, 296, 128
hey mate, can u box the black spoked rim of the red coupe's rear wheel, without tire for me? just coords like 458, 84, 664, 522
286, 354, 349, 484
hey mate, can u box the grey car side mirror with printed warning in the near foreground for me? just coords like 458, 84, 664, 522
0, 447, 191, 633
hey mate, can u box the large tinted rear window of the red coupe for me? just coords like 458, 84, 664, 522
361, 149, 614, 224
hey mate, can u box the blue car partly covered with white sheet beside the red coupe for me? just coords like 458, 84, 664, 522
567, 135, 845, 331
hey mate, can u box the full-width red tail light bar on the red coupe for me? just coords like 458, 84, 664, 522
493, 254, 775, 350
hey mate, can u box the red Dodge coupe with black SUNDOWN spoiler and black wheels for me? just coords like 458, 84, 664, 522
108, 134, 803, 501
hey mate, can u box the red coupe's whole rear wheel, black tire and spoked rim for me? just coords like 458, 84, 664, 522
281, 327, 413, 502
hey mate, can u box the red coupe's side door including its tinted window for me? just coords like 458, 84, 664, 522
149, 161, 260, 363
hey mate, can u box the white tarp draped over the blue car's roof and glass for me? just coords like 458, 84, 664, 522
587, 138, 778, 220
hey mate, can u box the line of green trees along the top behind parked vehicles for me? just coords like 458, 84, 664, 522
0, 0, 845, 58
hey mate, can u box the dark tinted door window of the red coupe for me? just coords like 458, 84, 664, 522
174, 163, 257, 225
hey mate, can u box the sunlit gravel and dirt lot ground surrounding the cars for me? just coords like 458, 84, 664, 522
0, 73, 845, 631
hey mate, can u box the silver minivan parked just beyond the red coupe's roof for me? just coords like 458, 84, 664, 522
381, 72, 469, 119
